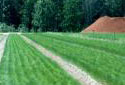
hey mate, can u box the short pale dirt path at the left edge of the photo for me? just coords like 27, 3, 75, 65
0, 33, 9, 62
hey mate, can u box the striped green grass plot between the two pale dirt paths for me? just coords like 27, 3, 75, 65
0, 35, 79, 85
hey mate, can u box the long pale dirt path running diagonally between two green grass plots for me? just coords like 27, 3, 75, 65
20, 35, 102, 85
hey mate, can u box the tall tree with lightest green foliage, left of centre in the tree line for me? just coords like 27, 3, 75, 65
32, 0, 55, 31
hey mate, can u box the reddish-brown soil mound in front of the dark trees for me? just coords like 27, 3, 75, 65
83, 16, 125, 32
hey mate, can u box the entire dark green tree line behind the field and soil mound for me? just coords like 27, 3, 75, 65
0, 0, 125, 32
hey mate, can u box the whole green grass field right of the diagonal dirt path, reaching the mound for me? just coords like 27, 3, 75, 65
24, 33, 125, 85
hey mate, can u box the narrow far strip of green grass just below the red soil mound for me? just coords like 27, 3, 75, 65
52, 32, 125, 40
